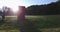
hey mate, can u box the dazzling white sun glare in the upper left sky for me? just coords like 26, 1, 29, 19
0, 0, 28, 13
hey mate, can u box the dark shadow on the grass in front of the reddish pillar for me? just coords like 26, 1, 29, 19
20, 19, 41, 32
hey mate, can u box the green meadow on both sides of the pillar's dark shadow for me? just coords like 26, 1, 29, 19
0, 15, 60, 32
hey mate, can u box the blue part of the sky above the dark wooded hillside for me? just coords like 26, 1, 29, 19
22, 0, 57, 6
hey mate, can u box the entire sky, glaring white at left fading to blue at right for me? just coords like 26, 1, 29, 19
0, 0, 57, 11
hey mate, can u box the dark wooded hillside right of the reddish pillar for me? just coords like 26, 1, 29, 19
26, 1, 60, 15
